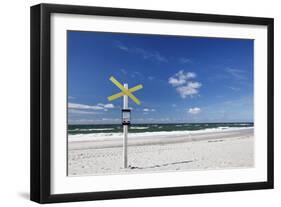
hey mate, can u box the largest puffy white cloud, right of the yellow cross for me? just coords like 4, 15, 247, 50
168, 70, 202, 98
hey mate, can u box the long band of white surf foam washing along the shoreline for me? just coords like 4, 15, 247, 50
68, 127, 253, 142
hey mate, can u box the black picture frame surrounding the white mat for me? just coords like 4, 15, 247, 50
30, 4, 274, 203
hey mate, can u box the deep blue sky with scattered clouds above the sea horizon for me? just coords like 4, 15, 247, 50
67, 31, 254, 124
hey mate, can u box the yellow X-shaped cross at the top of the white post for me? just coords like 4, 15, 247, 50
107, 76, 143, 105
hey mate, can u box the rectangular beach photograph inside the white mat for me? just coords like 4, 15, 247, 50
66, 30, 255, 176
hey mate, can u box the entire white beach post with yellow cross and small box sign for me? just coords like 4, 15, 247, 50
107, 76, 143, 168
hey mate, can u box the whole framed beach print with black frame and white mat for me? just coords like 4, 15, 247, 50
31, 4, 273, 203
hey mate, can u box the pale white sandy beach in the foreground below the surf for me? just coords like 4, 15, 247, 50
68, 128, 254, 176
